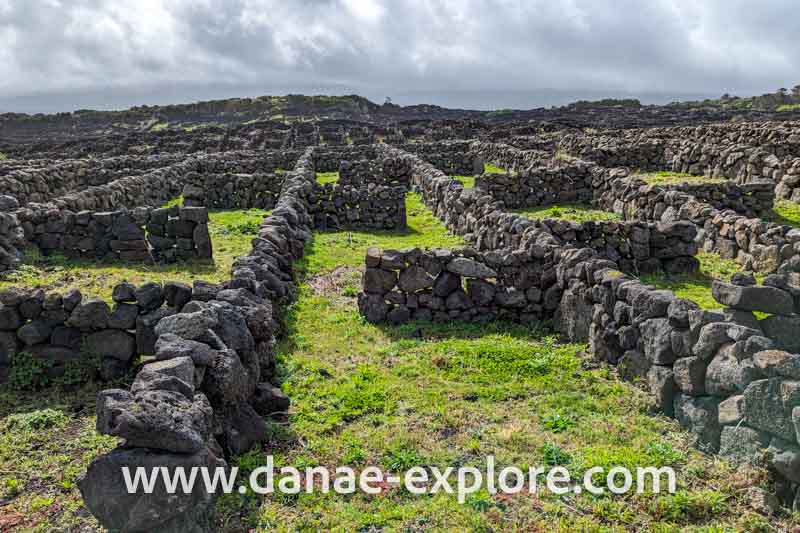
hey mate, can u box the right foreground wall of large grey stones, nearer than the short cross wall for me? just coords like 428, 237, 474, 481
555, 245, 800, 505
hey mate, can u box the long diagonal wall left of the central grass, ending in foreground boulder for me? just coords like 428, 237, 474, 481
79, 150, 315, 531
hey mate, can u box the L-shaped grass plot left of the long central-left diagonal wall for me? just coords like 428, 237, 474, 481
0, 209, 268, 301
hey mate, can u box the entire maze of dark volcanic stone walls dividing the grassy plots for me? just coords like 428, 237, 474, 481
0, 116, 800, 531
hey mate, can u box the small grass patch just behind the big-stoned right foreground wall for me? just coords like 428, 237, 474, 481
642, 251, 752, 309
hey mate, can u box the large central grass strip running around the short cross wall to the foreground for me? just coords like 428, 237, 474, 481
209, 204, 787, 531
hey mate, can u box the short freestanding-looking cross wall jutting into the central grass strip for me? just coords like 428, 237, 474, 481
358, 248, 561, 323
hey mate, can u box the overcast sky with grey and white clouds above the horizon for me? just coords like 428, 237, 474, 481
0, 0, 800, 110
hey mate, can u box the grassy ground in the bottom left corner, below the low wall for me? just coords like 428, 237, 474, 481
0, 383, 116, 533
